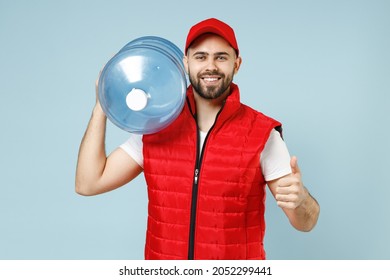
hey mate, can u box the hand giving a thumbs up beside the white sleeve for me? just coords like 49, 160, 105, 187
274, 156, 309, 209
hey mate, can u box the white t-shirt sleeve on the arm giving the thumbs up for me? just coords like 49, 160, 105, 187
260, 129, 291, 181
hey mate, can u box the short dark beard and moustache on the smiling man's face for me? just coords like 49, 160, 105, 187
188, 71, 233, 99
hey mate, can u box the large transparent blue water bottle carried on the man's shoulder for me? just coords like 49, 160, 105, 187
98, 36, 187, 134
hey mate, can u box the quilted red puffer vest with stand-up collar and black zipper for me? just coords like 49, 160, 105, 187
143, 84, 281, 259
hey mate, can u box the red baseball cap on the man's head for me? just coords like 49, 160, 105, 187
185, 18, 239, 55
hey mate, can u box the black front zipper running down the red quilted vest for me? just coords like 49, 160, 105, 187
188, 100, 225, 260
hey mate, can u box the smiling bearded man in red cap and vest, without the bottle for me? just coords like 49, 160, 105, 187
76, 19, 319, 259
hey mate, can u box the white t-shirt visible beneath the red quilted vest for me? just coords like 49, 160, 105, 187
120, 129, 291, 181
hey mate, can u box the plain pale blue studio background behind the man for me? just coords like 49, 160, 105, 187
0, 0, 390, 259
